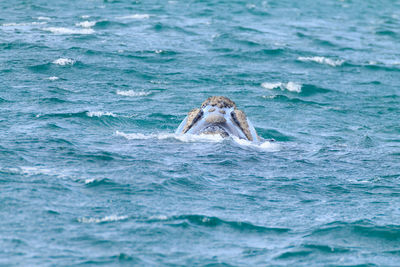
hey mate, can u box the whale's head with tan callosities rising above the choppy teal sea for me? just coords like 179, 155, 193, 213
176, 96, 259, 142
